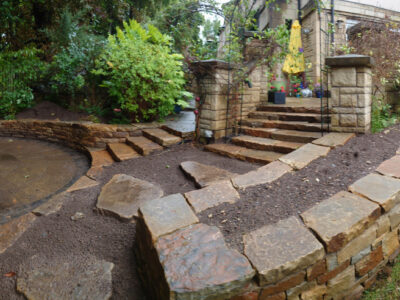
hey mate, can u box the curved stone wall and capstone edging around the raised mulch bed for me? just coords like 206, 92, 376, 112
135, 133, 400, 300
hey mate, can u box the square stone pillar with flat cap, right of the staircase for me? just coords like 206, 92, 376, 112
325, 55, 373, 133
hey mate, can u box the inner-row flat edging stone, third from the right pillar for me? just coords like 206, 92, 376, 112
232, 161, 293, 189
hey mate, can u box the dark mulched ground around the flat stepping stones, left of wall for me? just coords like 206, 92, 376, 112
0, 144, 258, 300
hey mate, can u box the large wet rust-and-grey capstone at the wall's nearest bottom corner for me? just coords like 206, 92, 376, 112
155, 224, 255, 300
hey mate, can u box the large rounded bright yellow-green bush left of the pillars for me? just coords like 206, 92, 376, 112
93, 20, 191, 122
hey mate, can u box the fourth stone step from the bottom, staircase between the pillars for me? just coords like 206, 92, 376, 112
241, 118, 328, 132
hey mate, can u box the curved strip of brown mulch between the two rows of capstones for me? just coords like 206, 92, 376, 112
200, 125, 400, 251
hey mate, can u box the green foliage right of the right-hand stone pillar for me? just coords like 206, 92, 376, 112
371, 97, 398, 132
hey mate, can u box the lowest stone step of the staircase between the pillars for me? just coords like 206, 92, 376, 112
205, 144, 283, 164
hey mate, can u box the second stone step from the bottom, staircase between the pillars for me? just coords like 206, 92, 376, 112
232, 135, 304, 153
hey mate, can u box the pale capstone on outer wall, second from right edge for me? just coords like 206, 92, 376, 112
349, 174, 400, 212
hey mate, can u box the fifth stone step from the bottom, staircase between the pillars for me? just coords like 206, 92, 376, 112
249, 111, 329, 123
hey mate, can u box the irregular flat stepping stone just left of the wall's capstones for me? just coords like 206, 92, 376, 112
96, 174, 164, 220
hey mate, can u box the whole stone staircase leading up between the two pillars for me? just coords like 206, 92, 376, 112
205, 98, 329, 164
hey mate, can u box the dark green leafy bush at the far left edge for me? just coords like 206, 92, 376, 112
0, 48, 45, 119
